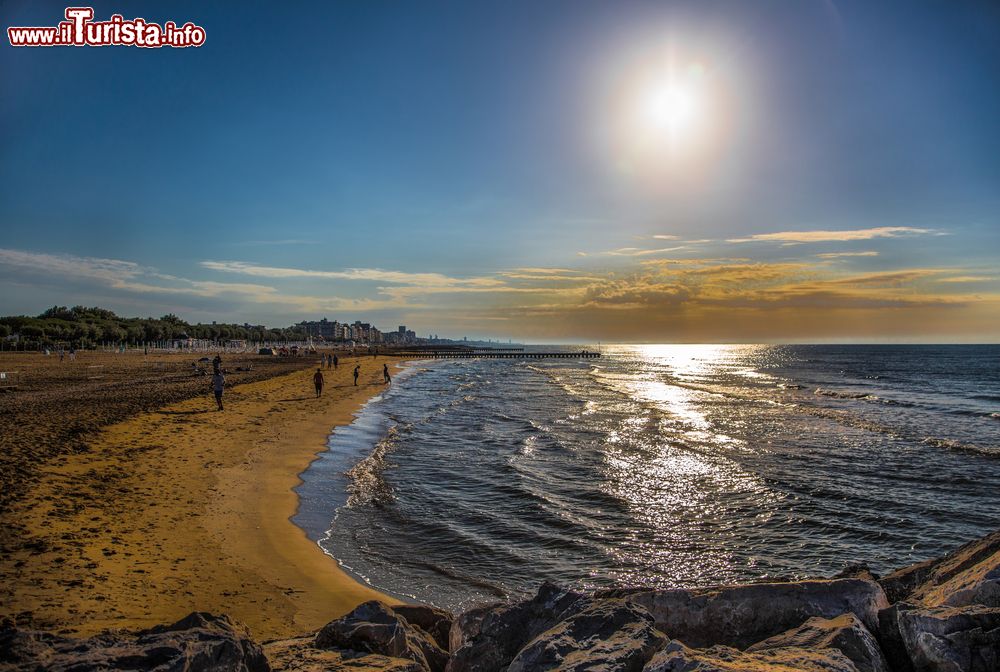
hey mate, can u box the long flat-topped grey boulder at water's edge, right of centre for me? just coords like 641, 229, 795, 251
628, 579, 888, 649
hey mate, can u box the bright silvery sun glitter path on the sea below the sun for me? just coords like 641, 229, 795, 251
588, 345, 780, 585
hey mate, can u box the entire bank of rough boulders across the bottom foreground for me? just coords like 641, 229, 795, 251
0, 532, 1000, 672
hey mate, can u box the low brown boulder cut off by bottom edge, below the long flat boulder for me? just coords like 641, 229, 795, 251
644, 642, 857, 672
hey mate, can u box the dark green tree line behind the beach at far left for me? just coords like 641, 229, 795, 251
0, 306, 306, 348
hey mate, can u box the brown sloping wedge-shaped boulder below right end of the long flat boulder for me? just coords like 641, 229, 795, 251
747, 614, 889, 672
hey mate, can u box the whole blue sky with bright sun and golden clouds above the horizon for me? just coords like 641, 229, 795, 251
0, 0, 1000, 342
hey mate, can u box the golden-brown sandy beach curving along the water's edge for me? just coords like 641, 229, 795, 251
0, 357, 402, 639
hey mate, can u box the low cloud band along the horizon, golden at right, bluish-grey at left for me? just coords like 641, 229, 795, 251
0, 248, 1000, 341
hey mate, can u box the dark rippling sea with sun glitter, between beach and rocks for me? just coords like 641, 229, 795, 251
293, 345, 1000, 611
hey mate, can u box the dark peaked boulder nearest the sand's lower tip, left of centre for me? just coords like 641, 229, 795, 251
314, 600, 448, 672
